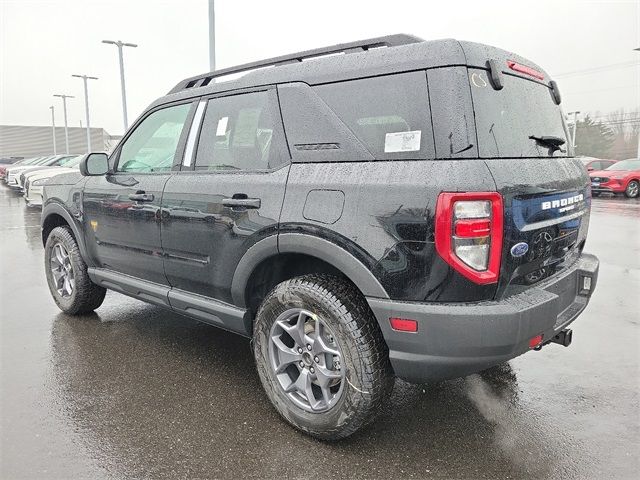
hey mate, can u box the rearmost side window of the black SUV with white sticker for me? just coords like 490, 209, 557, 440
314, 72, 434, 160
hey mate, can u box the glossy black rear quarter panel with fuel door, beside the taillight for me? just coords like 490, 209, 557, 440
280, 160, 496, 301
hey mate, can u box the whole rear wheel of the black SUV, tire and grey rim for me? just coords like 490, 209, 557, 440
253, 275, 393, 440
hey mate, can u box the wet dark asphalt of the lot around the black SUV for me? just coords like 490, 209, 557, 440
0, 186, 640, 479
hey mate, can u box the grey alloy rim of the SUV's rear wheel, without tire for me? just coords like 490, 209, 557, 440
269, 308, 345, 413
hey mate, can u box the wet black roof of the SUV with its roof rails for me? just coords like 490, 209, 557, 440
151, 34, 546, 107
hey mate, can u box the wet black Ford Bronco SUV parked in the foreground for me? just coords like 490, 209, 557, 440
42, 35, 598, 439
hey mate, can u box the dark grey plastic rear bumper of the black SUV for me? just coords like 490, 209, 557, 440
367, 254, 599, 383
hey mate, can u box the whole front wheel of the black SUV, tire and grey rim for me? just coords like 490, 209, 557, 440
44, 227, 107, 315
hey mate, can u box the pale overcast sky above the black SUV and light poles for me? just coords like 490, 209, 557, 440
0, 0, 640, 134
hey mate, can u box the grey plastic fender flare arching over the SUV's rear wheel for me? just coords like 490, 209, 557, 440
231, 233, 389, 307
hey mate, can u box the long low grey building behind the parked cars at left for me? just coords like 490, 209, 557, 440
0, 125, 121, 158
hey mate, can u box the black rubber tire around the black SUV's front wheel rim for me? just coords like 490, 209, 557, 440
44, 227, 107, 315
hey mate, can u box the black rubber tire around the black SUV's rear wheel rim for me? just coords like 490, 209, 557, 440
253, 274, 393, 440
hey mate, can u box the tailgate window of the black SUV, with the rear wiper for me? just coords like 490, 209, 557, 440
469, 68, 572, 158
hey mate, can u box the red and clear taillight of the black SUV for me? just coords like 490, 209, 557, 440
436, 192, 503, 284
